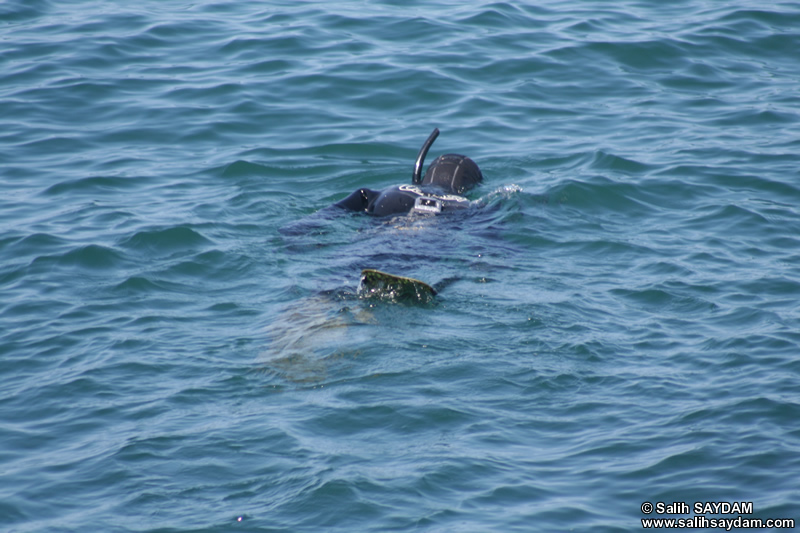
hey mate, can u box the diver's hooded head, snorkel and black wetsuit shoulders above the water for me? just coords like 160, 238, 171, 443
333, 128, 483, 217
